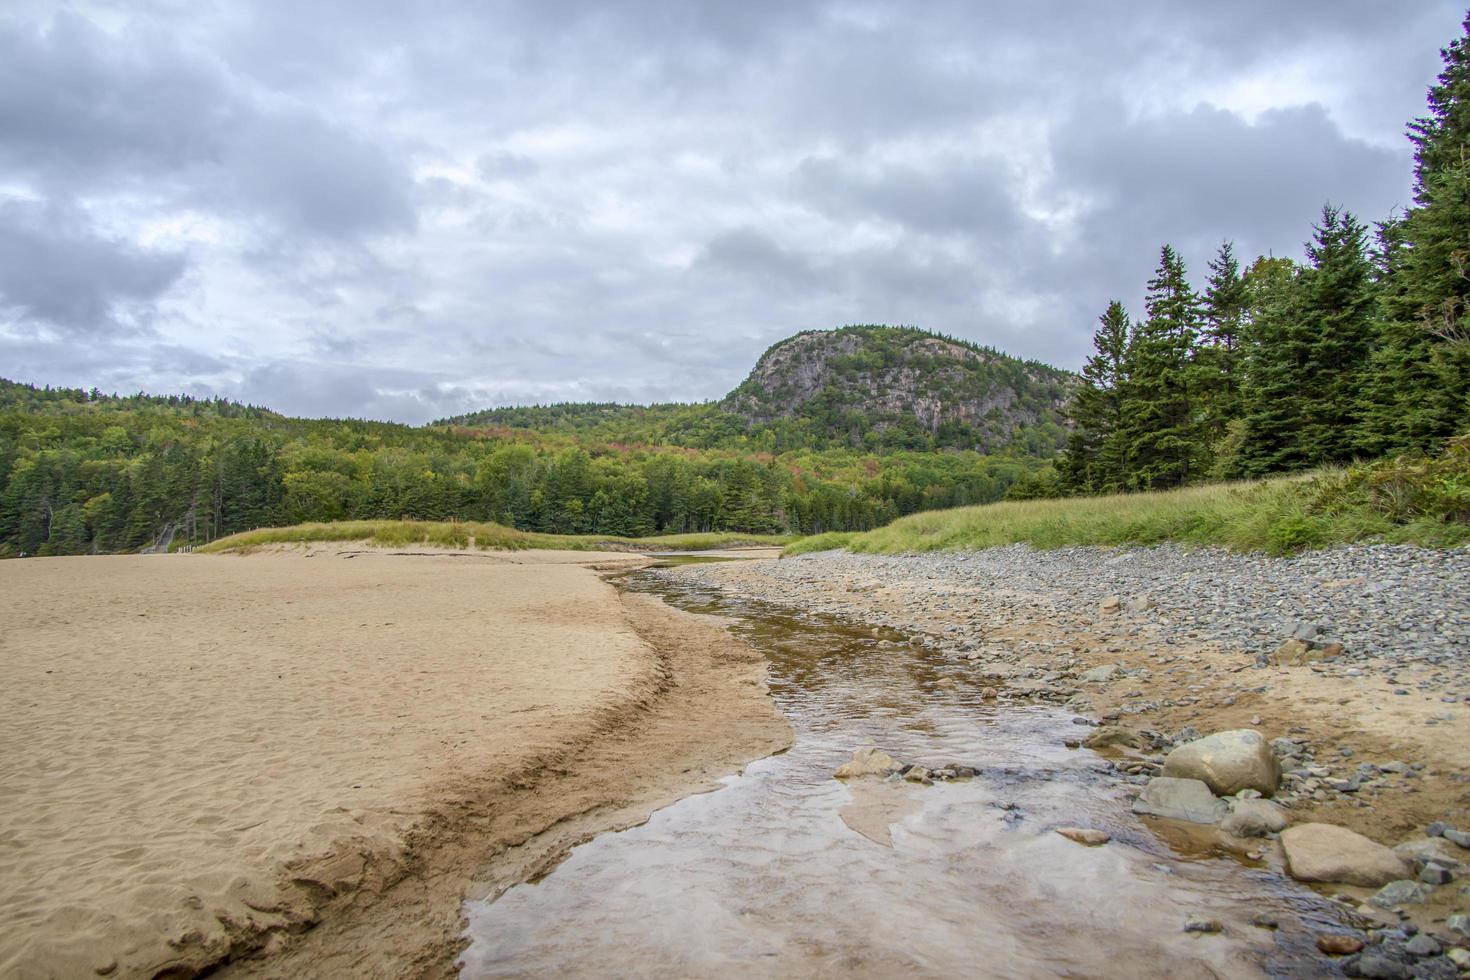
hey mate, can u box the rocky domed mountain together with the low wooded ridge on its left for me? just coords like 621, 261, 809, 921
444, 326, 1076, 457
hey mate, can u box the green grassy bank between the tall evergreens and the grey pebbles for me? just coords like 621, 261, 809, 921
786, 438, 1470, 554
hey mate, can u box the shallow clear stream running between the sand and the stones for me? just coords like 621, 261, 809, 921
462, 573, 1336, 977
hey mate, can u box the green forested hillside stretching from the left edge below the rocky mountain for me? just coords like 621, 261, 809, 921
0, 382, 1042, 555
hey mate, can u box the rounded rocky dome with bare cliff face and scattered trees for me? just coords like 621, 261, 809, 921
720, 326, 1075, 451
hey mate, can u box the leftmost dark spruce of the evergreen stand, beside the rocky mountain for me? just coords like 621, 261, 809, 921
1057, 300, 1132, 492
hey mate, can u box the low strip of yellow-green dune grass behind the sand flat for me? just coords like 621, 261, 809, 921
198, 520, 792, 551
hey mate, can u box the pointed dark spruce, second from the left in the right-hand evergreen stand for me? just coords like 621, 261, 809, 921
1119, 245, 1208, 489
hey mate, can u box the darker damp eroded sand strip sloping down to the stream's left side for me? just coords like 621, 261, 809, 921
214, 575, 791, 977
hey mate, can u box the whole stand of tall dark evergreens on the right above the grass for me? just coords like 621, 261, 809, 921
1058, 16, 1470, 494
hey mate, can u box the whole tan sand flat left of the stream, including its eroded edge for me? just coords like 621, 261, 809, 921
0, 547, 789, 977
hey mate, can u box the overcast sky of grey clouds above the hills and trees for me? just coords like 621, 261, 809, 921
0, 0, 1466, 423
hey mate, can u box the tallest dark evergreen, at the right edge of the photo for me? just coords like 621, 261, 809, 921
1360, 15, 1470, 454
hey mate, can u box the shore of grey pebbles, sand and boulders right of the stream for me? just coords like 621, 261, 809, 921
669, 545, 1470, 977
